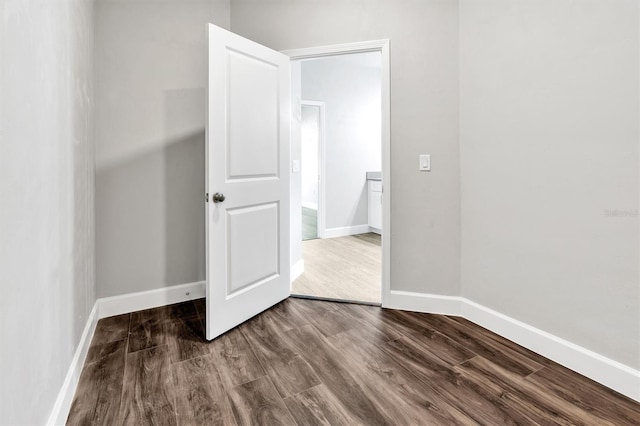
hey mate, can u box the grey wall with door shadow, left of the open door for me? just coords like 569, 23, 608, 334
96, 0, 229, 297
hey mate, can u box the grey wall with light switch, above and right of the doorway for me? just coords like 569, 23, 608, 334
231, 0, 460, 295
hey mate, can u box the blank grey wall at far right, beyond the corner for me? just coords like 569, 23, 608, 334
460, 0, 640, 369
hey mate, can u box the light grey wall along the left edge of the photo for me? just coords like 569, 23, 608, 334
0, 0, 95, 425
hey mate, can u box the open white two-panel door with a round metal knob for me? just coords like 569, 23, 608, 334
206, 24, 291, 339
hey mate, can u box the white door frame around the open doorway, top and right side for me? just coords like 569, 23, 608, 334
282, 40, 391, 307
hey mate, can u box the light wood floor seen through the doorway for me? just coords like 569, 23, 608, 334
291, 233, 382, 303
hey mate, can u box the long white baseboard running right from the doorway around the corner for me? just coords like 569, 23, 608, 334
384, 291, 640, 402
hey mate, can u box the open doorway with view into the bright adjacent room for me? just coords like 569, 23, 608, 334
291, 50, 384, 304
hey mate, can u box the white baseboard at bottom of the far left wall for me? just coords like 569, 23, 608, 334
47, 301, 99, 425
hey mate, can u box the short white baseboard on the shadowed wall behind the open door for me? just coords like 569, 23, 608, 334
98, 281, 206, 318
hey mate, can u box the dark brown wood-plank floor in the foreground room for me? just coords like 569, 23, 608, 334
67, 299, 640, 425
